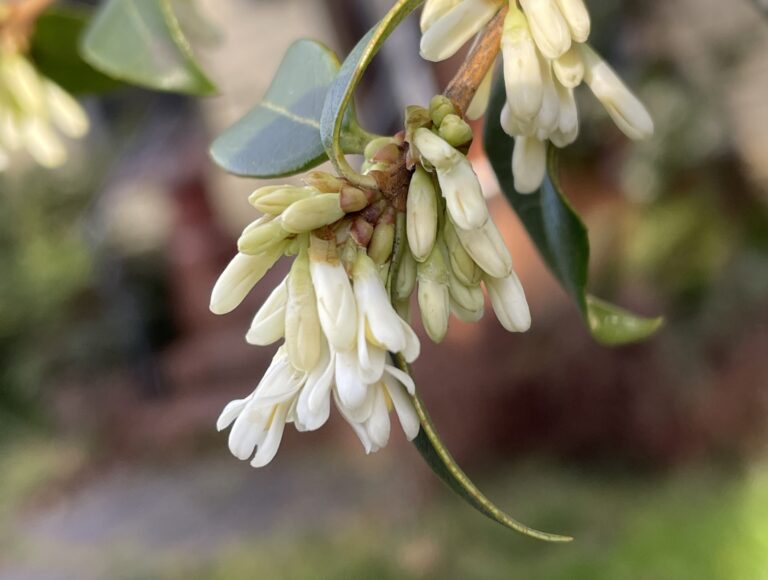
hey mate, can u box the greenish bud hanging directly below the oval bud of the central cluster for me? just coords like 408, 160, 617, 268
417, 244, 451, 343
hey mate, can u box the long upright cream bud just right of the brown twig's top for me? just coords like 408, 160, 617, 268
501, 6, 544, 120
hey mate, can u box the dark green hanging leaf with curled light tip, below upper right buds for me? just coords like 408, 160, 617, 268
485, 81, 662, 345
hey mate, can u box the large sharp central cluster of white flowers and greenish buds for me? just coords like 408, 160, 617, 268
210, 98, 530, 467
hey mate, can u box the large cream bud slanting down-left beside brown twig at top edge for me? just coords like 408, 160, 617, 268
421, 0, 501, 62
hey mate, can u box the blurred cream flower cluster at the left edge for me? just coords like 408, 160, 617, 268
0, 48, 88, 170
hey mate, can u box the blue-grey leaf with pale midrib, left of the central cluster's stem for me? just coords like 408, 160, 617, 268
211, 40, 354, 178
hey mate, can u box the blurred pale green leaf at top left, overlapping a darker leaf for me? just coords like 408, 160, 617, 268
80, 0, 216, 95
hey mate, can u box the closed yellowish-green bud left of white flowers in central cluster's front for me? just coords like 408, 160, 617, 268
285, 246, 322, 372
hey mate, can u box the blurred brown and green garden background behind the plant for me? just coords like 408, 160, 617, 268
0, 0, 768, 580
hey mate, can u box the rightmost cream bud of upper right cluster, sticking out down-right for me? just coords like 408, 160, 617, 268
579, 44, 653, 140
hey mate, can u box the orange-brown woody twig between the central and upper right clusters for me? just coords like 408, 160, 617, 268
443, 5, 509, 114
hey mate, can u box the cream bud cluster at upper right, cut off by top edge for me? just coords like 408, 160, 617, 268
421, 0, 653, 193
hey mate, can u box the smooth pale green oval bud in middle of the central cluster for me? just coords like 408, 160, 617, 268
405, 166, 437, 262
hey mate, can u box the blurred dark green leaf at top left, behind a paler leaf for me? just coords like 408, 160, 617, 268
30, 7, 120, 94
